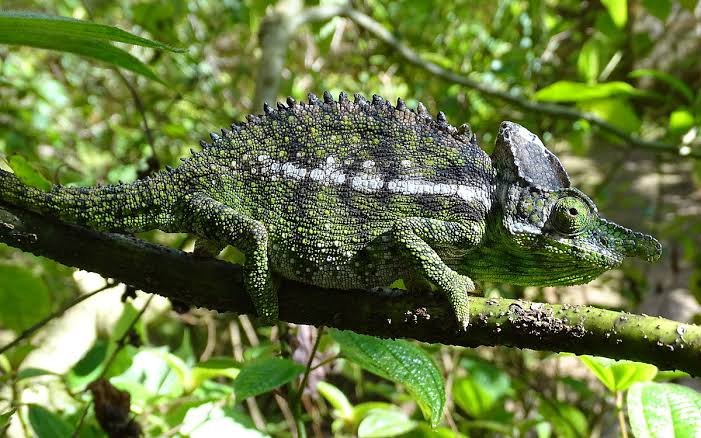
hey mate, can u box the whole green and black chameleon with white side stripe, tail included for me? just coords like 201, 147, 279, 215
0, 93, 661, 328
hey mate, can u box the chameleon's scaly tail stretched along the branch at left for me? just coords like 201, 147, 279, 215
0, 170, 177, 233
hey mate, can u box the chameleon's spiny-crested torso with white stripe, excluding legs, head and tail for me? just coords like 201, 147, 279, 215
181, 96, 494, 288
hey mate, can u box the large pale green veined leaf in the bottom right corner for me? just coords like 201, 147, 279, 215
627, 382, 701, 438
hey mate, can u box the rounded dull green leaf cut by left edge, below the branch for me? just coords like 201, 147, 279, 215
0, 265, 51, 332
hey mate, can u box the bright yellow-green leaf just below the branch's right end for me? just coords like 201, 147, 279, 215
579, 356, 657, 392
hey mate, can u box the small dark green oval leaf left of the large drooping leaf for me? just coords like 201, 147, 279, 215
234, 357, 304, 400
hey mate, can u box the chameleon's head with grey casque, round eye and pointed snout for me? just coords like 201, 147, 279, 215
482, 122, 661, 285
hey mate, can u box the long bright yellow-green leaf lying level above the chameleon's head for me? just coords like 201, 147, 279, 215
535, 81, 636, 102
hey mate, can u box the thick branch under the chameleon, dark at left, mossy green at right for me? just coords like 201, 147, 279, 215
0, 204, 701, 376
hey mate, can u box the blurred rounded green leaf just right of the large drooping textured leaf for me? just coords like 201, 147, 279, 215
453, 359, 511, 419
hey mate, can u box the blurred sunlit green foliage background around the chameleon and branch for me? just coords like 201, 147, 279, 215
0, 0, 701, 437
